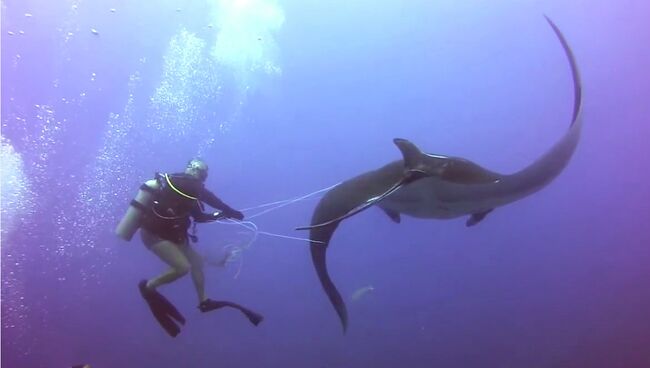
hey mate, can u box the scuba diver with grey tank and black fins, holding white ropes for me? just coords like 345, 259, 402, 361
115, 158, 263, 337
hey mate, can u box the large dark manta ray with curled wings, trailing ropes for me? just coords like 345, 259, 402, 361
297, 16, 582, 333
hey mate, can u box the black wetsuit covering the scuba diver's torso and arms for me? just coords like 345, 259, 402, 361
141, 173, 244, 244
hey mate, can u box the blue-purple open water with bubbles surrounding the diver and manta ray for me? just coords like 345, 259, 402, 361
0, 0, 650, 368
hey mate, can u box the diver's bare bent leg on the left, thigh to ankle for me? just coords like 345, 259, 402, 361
141, 229, 190, 289
